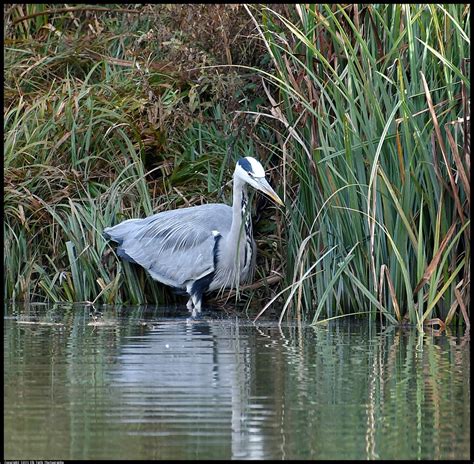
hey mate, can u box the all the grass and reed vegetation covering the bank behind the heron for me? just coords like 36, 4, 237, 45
4, 4, 470, 329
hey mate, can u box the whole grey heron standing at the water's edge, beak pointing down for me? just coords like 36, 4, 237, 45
104, 157, 283, 315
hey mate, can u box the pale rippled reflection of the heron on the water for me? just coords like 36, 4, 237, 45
110, 320, 271, 459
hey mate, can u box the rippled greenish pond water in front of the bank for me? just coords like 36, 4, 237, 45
4, 305, 470, 460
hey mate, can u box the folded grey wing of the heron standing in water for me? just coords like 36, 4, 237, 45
104, 204, 232, 288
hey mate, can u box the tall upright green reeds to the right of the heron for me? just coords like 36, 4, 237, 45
247, 4, 470, 330
